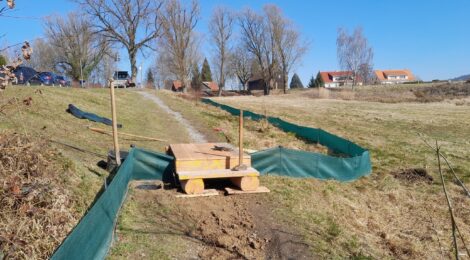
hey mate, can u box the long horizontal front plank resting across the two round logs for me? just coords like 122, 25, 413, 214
177, 167, 259, 180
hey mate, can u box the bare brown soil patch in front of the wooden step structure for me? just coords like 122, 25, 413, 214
126, 183, 310, 259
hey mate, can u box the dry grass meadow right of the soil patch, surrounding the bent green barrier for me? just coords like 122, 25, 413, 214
158, 89, 470, 258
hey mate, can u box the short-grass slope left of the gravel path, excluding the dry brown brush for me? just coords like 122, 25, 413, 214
0, 87, 189, 258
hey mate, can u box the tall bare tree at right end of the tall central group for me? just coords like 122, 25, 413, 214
264, 5, 307, 94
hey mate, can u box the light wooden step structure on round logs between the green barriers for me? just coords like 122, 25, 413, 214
167, 143, 259, 194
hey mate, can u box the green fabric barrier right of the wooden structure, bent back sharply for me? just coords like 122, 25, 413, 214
203, 99, 372, 181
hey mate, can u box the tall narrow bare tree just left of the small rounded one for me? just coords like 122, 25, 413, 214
209, 7, 235, 96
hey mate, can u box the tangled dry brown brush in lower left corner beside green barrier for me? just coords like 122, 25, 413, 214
0, 134, 78, 259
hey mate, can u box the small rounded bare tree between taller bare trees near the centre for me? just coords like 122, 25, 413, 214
230, 45, 253, 90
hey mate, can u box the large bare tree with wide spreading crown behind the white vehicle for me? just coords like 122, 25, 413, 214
76, 0, 162, 82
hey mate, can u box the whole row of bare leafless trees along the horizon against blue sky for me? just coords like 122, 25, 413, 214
0, 0, 373, 95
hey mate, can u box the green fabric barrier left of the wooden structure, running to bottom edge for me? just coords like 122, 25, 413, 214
51, 148, 173, 260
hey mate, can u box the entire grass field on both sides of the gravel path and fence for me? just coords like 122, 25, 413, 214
0, 87, 470, 259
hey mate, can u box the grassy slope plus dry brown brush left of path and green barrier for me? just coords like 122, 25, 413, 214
0, 86, 189, 259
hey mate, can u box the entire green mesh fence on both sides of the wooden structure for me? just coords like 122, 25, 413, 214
51, 99, 371, 260
